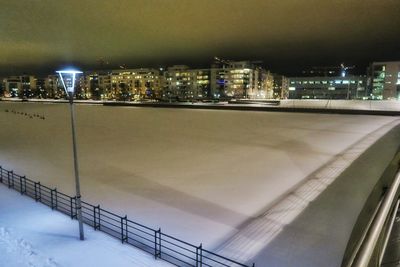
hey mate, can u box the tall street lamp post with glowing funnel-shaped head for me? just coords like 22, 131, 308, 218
57, 70, 85, 240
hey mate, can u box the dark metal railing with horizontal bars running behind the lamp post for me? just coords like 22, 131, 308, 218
0, 166, 255, 267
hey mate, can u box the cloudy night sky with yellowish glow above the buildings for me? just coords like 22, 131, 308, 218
0, 0, 400, 75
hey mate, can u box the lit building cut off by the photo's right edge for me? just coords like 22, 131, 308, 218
367, 61, 400, 99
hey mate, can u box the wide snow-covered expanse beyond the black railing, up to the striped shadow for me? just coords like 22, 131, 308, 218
0, 103, 398, 266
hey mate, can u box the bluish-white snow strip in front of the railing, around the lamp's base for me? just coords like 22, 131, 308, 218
0, 184, 172, 267
